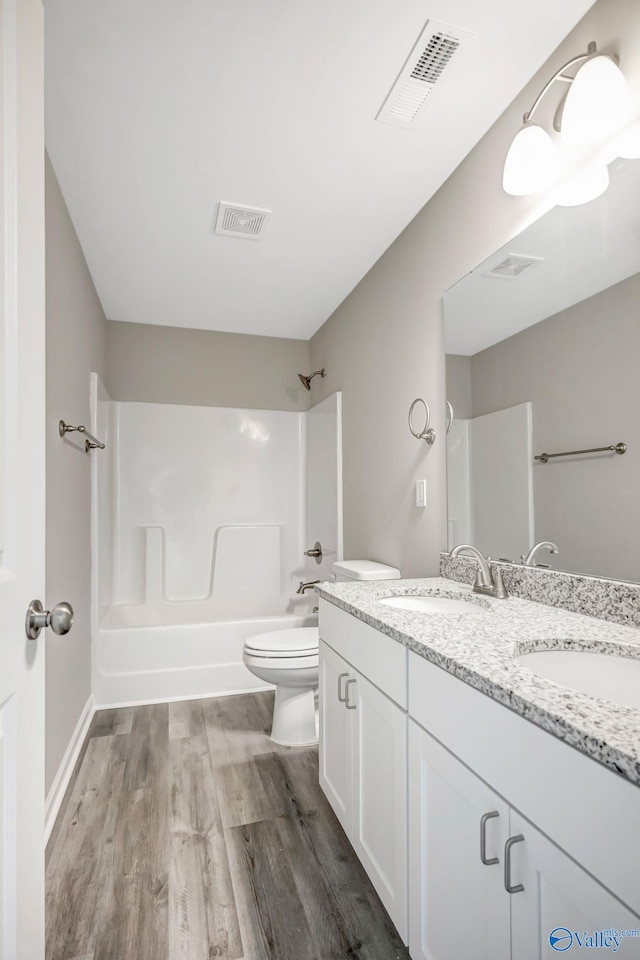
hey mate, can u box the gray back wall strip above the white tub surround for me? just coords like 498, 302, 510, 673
107, 322, 318, 410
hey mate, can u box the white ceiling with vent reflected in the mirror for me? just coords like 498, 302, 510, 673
445, 160, 640, 356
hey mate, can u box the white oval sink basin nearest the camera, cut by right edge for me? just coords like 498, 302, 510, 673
516, 650, 640, 710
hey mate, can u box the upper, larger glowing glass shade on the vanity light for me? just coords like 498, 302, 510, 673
560, 56, 631, 144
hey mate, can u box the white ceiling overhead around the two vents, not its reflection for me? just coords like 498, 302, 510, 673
45, 0, 593, 339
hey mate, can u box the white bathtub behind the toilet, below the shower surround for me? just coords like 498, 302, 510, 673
93, 607, 318, 707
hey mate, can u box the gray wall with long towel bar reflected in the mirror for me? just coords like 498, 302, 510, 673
471, 274, 640, 580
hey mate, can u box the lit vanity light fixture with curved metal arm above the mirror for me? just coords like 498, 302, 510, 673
502, 42, 630, 202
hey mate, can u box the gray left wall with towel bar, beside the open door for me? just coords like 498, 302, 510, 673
45, 158, 106, 791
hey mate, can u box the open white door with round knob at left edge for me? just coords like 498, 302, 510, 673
0, 0, 45, 960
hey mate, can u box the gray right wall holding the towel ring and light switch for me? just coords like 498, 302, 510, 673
311, 0, 640, 576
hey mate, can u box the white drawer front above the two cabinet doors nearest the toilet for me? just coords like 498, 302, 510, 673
320, 599, 408, 710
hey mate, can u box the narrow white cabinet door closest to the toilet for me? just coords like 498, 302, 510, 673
319, 641, 356, 837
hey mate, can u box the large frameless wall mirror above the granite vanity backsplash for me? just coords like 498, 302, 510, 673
445, 160, 640, 581
